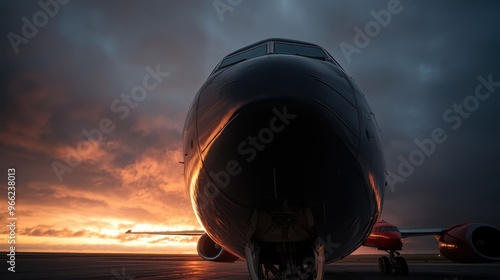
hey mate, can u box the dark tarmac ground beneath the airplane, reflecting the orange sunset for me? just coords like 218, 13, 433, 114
0, 253, 500, 280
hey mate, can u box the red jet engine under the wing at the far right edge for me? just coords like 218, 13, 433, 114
437, 224, 500, 263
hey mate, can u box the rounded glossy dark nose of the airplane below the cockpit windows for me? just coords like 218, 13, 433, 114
197, 55, 359, 208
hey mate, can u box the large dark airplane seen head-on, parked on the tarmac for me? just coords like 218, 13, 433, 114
127, 38, 500, 280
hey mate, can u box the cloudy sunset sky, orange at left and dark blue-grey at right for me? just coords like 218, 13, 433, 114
0, 0, 500, 253
